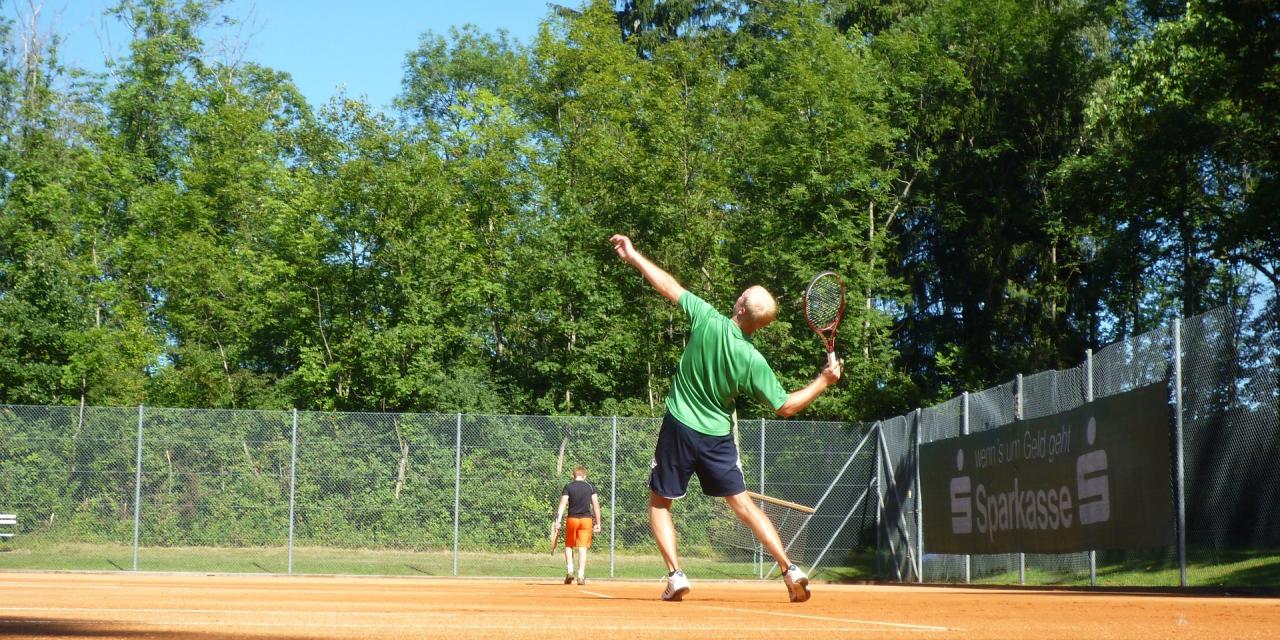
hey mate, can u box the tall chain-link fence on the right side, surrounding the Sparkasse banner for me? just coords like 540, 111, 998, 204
882, 305, 1280, 586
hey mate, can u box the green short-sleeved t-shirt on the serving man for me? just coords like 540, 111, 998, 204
667, 291, 787, 435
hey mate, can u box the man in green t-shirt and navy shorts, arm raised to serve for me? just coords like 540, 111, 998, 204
609, 234, 842, 602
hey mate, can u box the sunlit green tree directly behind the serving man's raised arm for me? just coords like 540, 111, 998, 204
525, 3, 736, 411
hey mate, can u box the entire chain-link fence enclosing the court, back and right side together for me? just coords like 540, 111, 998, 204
0, 307, 1280, 585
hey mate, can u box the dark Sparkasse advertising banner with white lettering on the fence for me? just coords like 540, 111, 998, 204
920, 383, 1174, 554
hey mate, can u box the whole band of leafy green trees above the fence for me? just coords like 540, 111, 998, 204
0, 0, 1280, 419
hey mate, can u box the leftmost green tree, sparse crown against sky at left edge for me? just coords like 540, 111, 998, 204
0, 5, 155, 407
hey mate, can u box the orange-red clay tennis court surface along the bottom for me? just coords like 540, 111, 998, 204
0, 573, 1280, 640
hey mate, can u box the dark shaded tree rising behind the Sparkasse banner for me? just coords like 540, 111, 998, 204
879, 0, 1107, 393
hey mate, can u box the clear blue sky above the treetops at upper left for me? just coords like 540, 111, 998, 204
0, 0, 555, 108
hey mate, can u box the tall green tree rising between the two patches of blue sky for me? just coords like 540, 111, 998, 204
97, 0, 317, 407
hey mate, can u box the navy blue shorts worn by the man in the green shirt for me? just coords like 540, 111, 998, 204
649, 413, 746, 498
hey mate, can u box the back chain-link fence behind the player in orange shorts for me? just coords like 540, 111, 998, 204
0, 406, 876, 577
